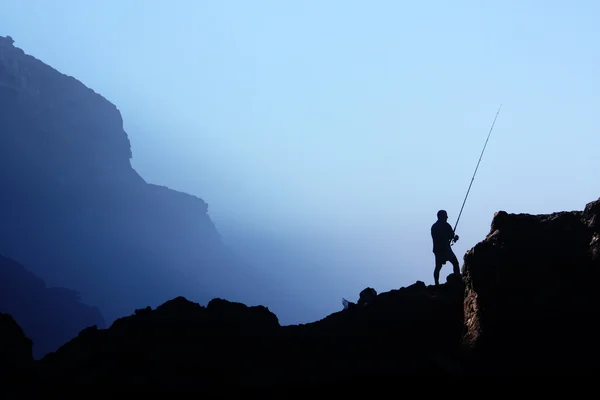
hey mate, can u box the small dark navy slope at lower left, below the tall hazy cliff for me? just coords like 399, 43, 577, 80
0, 252, 105, 358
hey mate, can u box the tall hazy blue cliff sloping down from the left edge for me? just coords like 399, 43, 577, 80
0, 33, 238, 321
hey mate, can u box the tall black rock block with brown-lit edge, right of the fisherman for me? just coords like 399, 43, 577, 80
464, 199, 600, 374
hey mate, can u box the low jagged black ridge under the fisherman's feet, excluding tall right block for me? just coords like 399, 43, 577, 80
28, 276, 464, 394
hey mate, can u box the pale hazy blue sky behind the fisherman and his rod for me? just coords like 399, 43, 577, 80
0, 0, 600, 304
